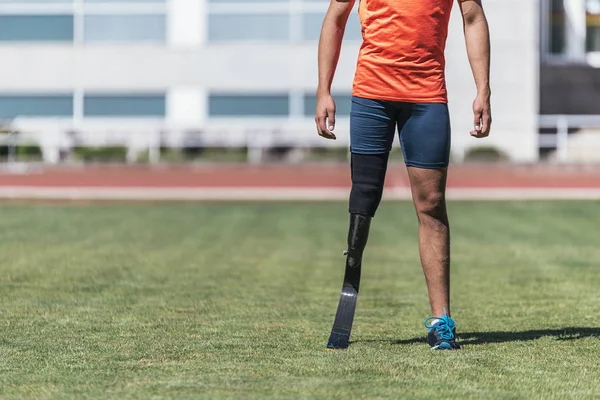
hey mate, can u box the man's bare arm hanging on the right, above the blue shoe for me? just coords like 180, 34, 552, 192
458, 0, 492, 138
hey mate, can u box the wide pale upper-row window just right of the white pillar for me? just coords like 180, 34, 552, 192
208, 13, 290, 42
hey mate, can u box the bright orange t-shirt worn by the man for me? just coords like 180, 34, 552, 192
352, 0, 454, 103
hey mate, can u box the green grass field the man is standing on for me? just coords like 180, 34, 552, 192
0, 202, 600, 399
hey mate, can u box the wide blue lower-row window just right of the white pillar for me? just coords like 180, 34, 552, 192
208, 94, 290, 117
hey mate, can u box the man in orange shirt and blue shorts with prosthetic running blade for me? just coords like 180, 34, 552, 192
315, 0, 491, 349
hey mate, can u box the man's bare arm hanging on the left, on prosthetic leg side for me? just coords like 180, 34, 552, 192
315, 0, 354, 139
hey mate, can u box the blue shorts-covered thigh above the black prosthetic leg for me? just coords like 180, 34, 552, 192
350, 97, 396, 154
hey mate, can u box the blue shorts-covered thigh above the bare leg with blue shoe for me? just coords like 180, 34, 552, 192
399, 103, 450, 168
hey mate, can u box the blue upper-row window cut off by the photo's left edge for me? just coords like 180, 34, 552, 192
0, 15, 73, 42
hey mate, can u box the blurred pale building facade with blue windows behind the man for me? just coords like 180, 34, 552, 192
0, 0, 540, 162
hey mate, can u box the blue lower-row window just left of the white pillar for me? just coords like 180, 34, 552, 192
83, 94, 166, 117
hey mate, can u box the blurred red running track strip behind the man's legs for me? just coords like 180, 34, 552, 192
0, 164, 600, 189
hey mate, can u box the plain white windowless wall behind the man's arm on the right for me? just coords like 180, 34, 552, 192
446, 0, 539, 162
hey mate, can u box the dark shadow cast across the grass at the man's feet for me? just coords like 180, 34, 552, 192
350, 327, 600, 345
